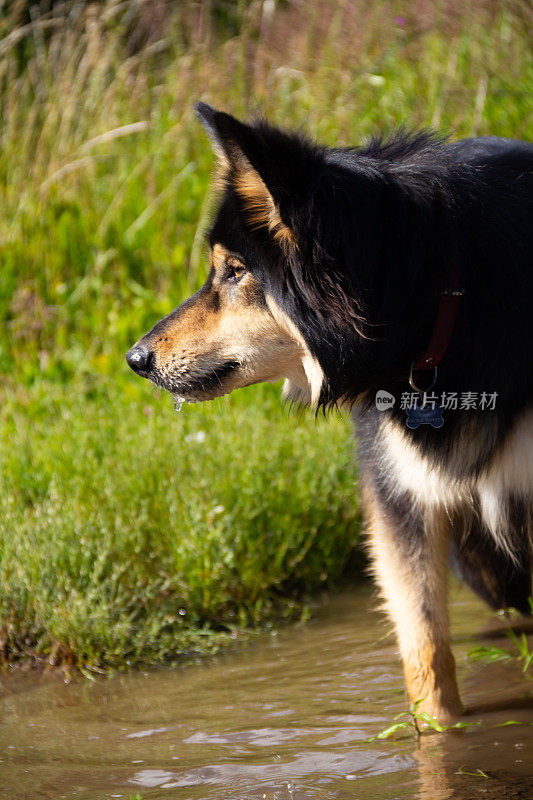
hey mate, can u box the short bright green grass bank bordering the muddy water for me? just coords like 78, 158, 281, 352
0, 383, 358, 667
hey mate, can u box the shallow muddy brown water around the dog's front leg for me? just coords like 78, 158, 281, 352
0, 587, 533, 800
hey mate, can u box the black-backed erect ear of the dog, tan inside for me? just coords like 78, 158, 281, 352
196, 103, 301, 247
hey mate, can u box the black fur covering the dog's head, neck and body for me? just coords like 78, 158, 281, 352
198, 106, 533, 611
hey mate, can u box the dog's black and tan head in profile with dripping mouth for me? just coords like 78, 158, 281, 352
127, 104, 376, 404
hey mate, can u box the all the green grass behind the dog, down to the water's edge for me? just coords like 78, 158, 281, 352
0, 0, 533, 668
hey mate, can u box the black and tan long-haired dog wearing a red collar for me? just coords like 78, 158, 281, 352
127, 104, 533, 721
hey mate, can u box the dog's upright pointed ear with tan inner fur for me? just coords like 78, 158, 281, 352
195, 103, 296, 247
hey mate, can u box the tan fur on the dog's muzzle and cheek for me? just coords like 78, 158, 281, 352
142, 243, 324, 402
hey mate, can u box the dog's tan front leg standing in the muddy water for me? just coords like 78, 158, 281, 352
363, 479, 462, 723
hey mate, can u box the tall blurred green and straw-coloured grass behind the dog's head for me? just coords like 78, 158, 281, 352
0, 0, 533, 388
